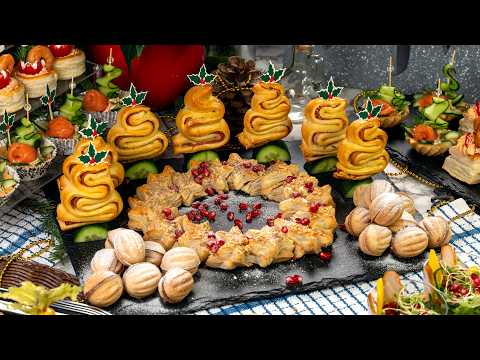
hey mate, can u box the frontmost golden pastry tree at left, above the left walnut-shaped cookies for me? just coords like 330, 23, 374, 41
57, 139, 123, 230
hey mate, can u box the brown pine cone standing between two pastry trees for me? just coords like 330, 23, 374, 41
213, 56, 261, 138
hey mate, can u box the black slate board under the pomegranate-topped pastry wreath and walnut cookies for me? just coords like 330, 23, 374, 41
45, 141, 426, 314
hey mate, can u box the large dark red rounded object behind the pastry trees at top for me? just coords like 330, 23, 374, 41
88, 45, 205, 109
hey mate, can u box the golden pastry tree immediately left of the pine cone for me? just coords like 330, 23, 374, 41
173, 85, 230, 154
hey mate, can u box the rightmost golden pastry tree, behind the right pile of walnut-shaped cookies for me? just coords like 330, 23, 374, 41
334, 118, 390, 180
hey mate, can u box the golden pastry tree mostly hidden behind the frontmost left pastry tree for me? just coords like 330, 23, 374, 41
72, 136, 125, 187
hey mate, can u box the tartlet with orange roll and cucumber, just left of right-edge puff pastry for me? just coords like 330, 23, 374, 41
404, 114, 460, 156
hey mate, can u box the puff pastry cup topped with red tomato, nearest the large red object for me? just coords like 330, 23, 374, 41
48, 45, 86, 80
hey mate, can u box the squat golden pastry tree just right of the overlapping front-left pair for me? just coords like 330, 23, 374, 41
107, 105, 168, 162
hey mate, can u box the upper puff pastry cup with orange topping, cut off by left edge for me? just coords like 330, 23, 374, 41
0, 54, 25, 114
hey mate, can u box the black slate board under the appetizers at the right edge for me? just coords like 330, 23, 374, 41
387, 114, 480, 208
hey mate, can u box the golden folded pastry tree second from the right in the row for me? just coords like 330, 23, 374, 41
300, 97, 348, 161
